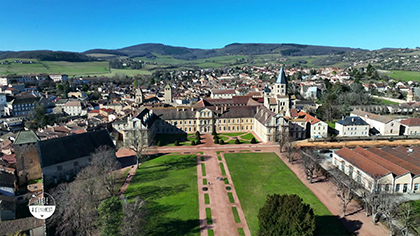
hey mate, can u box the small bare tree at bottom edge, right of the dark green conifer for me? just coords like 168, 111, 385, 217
121, 197, 146, 236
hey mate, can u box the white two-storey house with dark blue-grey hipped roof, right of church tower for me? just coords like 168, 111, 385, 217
335, 116, 370, 137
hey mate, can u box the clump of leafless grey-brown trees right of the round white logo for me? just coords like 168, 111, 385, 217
48, 148, 118, 236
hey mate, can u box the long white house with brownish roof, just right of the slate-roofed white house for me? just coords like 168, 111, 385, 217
350, 110, 400, 135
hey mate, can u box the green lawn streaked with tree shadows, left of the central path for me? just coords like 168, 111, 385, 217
125, 155, 200, 236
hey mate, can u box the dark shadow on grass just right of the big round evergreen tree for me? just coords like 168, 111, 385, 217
314, 216, 363, 235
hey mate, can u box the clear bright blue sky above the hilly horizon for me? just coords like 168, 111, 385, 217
0, 0, 420, 52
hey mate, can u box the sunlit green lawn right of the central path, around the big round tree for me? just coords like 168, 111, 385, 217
225, 153, 348, 235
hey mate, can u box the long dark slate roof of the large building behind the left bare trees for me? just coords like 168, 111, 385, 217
38, 130, 114, 168
